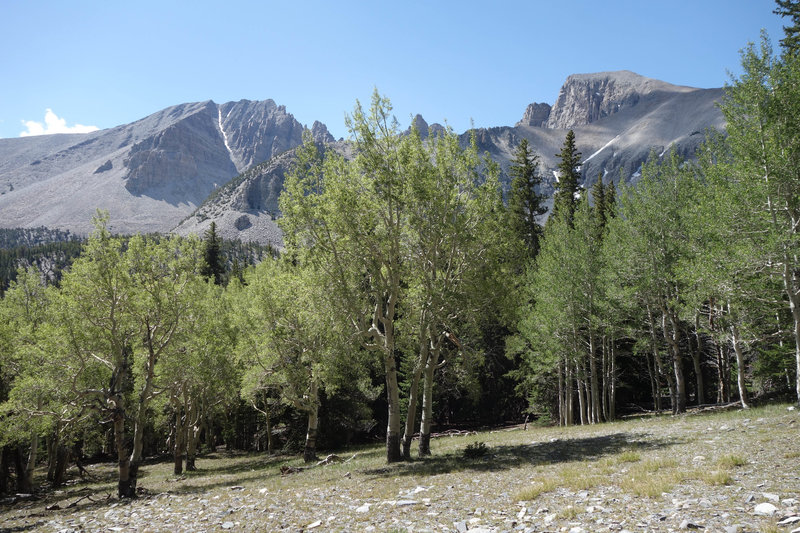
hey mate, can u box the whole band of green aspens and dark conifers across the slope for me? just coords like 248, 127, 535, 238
0, 15, 800, 497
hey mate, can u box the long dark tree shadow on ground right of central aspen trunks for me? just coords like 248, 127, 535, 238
362, 433, 682, 478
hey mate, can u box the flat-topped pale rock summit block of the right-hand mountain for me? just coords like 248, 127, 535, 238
548, 70, 697, 129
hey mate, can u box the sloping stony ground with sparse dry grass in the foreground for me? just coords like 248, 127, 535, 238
0, 405, 800, 533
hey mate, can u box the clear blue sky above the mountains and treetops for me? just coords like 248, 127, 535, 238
0, 0, 782, 138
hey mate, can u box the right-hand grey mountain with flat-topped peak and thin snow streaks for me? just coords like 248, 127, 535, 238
510, 71, 725, 193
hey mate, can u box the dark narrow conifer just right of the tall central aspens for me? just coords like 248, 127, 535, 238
508, 139, 547, 257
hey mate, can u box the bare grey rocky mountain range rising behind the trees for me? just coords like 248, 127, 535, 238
0, 71, 724, 244
